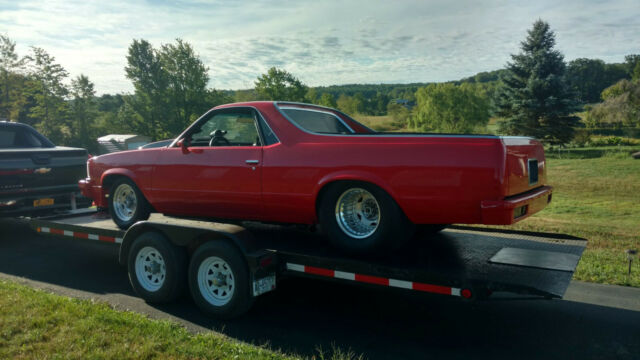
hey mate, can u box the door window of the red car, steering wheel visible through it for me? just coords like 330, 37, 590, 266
191, 109, 261, 147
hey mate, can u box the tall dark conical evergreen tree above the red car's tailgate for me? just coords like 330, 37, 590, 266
498, 20, 579, 144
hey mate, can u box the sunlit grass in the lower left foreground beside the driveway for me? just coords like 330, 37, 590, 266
0, 280, 358, 359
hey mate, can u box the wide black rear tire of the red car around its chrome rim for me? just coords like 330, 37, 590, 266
318, 181, 415, 253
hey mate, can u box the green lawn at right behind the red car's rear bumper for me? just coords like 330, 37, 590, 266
484, 147, 640, 287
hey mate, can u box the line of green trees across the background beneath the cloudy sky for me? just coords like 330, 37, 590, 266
0, 20, 640, 151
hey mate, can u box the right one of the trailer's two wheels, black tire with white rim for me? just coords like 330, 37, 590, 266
189, 241, 253, 319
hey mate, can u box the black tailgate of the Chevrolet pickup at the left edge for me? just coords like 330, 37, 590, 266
0, 147, 87, 196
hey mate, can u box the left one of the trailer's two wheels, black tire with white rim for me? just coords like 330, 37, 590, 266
127, 232, 187, 303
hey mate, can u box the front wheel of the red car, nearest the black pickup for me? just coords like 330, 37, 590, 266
109, 178, 151, 230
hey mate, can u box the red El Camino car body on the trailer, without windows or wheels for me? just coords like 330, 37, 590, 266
80, 102, 552, 224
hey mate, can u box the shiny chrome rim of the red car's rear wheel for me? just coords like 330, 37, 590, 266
335, 188, 380, 239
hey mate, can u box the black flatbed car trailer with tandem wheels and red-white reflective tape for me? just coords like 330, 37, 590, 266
30, 209, 587, 318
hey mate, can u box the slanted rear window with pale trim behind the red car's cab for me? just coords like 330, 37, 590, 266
280, 108, 353, 134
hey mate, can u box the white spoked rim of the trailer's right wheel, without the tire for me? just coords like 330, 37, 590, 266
198, 256, 236, 306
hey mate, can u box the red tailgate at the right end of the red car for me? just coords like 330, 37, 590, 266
502, 137, 547, 197
